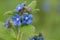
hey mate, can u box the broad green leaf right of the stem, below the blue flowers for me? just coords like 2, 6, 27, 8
20, 25, 35, 40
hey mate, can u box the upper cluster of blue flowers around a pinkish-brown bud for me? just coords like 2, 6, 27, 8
5, 3, 33, 26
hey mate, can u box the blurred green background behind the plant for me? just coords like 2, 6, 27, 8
0, 0, 60, 40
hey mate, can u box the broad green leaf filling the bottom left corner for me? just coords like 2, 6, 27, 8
0, 24, 16, 40
